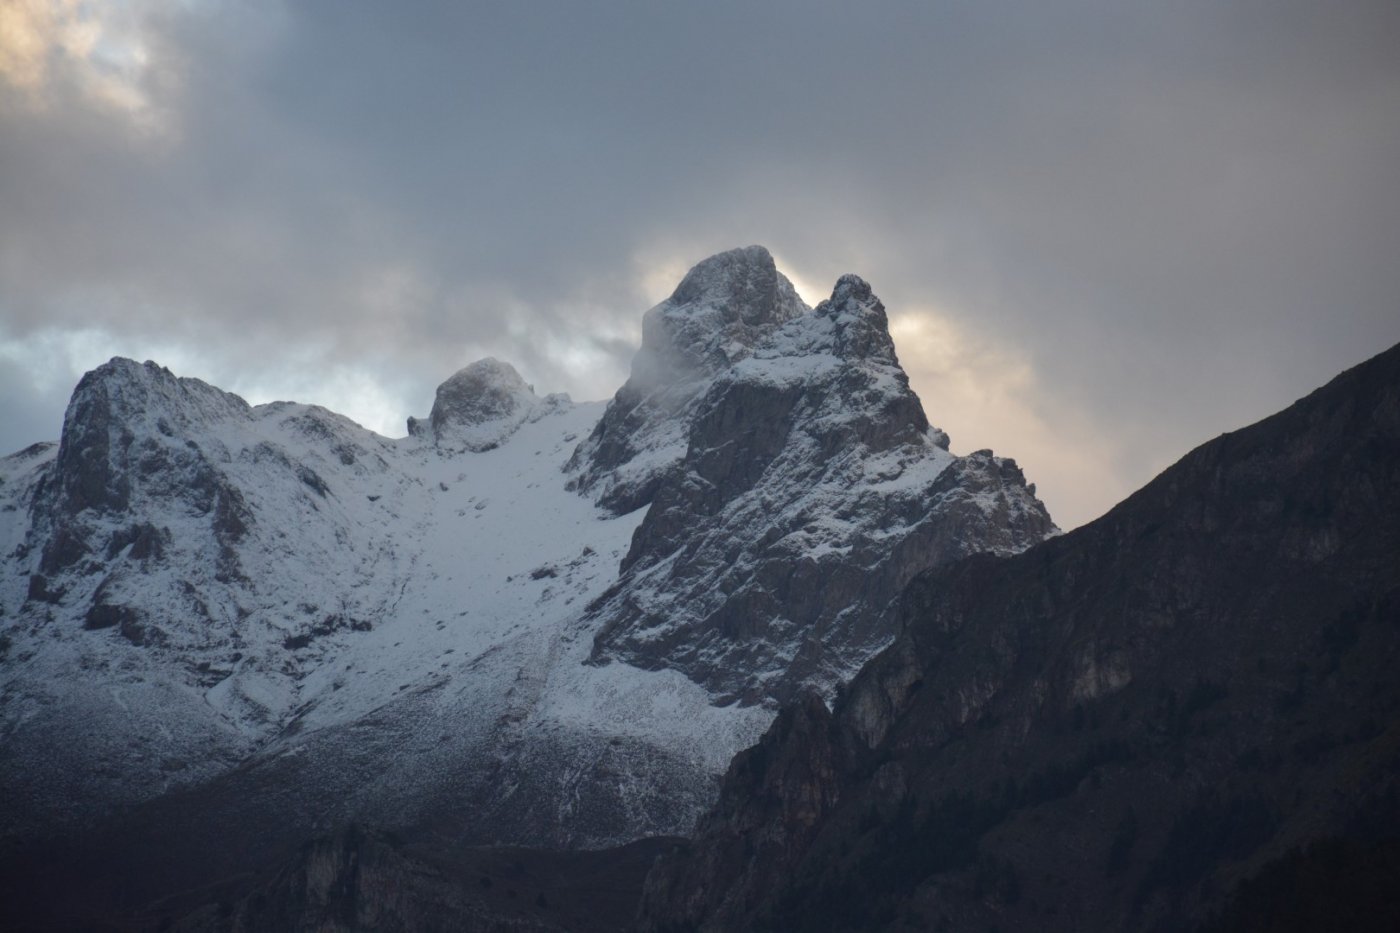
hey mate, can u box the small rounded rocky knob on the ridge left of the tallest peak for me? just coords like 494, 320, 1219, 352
409, 357, 540, 451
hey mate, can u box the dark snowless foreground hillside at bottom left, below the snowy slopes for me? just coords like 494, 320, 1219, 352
0, 825, 672, 933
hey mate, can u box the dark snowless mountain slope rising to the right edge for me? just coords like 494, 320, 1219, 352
641, 341, 1400, 932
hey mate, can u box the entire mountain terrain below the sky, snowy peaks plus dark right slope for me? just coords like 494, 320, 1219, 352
0, 247, 1400, 933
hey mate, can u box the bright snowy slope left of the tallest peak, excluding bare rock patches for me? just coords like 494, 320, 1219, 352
0, 360, 763, 841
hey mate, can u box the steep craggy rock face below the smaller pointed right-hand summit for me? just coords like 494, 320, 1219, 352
575, 267, 1054, 703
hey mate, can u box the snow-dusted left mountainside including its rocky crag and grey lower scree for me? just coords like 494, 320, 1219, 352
0, 353, 766, 845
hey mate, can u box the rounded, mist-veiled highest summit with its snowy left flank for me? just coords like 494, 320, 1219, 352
570, 247, 809, 514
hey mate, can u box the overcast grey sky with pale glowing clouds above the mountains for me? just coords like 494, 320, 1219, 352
0, 0, 1400, 528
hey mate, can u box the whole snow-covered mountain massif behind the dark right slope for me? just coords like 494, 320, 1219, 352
0, 247, 1054, 846
